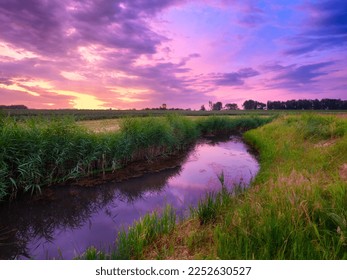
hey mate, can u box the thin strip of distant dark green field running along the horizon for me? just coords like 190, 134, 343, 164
0, 109, 346, 120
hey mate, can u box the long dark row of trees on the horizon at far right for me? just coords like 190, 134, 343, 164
268, 98, 347, 110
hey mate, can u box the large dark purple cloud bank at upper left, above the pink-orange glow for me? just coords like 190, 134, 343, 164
0, 0, 188, 56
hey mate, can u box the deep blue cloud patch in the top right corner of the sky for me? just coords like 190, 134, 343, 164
285, 0, 347, 55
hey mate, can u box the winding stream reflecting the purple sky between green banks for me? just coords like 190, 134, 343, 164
0, 137, 258, 259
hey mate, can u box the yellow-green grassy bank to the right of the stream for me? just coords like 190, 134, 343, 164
82, 114, 347, 259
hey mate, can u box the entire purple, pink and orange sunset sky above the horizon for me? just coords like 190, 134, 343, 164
0, 0, 347, 109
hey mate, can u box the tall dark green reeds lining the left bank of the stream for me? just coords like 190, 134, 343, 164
0, 115, 268, 201
